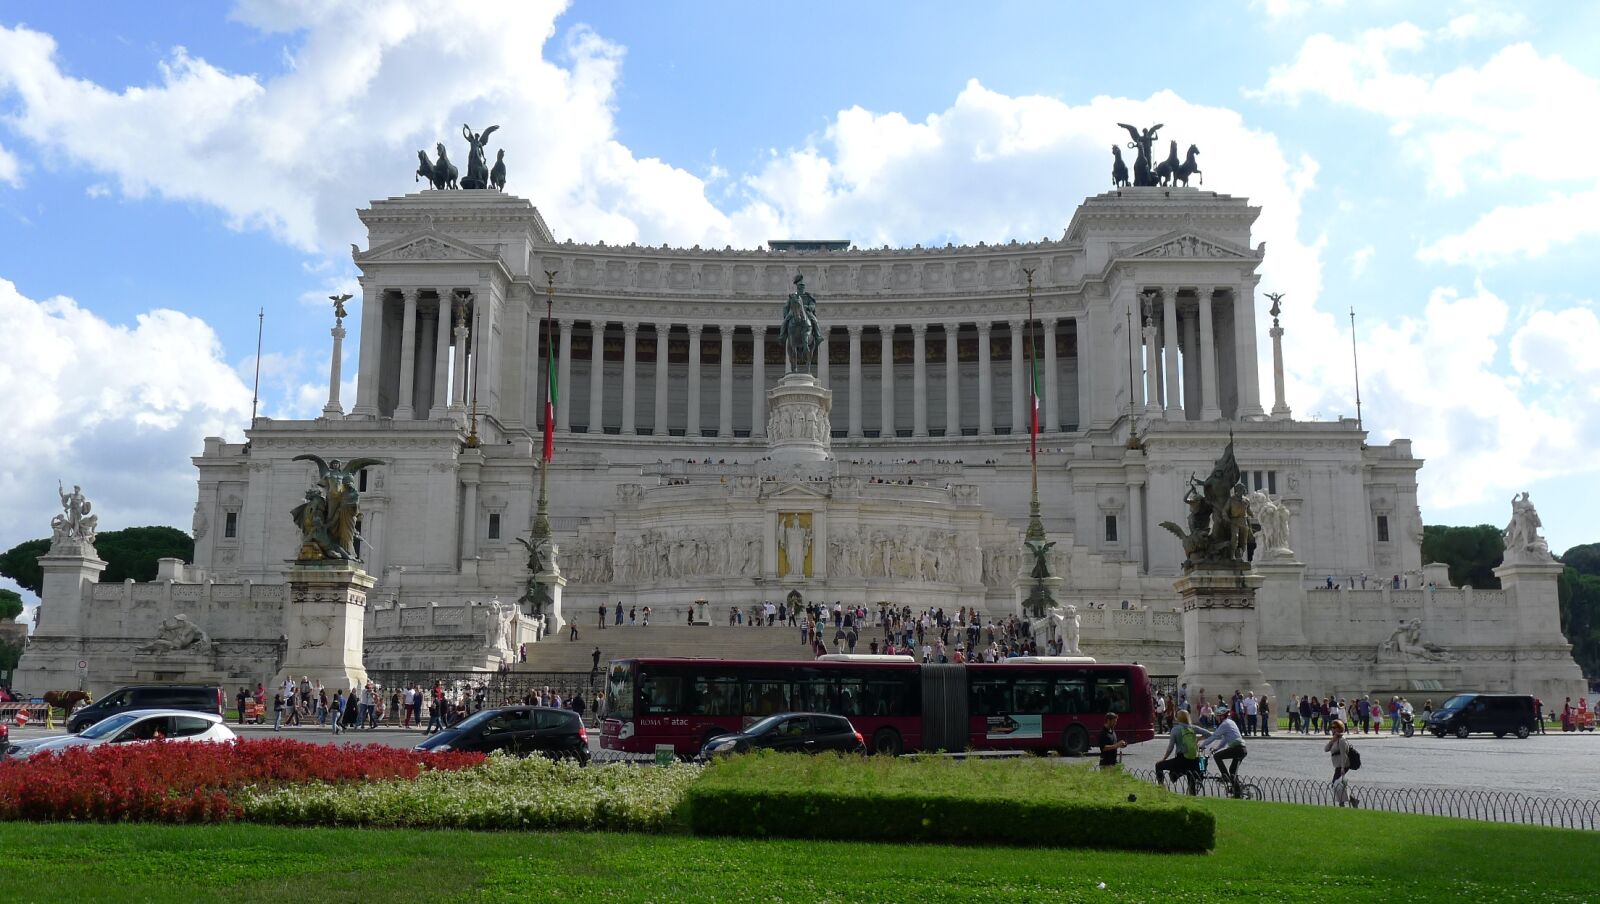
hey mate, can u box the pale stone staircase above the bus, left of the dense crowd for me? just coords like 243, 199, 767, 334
515, 624, 819, 672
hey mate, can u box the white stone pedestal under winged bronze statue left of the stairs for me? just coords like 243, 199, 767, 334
275, 562, 376, 690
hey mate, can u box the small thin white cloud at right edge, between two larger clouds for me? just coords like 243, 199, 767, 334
1416, 187, 1600, 267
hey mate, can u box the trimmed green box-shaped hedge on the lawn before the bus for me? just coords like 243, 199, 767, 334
686, 752, 1216, 853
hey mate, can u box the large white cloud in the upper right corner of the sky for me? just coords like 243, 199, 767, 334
1253, 31, 1600, 195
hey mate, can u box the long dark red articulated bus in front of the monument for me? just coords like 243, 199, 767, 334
600, 656, 1155, 757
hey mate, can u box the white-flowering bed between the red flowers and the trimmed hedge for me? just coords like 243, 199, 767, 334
238, 757, 701, 832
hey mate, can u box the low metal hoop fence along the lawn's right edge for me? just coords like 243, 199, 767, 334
1126, 770, 1600, 830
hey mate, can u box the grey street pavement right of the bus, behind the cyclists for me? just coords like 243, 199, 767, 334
1122, 731, 1600, 798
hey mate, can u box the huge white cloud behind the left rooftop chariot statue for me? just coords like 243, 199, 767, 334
0, 0, 760, 256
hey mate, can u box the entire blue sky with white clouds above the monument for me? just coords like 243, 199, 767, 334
0, 0, 1600, 604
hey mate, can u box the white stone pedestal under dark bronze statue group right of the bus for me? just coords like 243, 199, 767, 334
1173, 563, 1272, 698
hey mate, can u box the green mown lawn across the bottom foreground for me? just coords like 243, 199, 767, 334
0, 800, 1600, 904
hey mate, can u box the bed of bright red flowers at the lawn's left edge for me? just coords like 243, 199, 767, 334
0, 739, 483, 822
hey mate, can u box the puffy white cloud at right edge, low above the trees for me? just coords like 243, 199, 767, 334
1362, 285, 1600, 510
